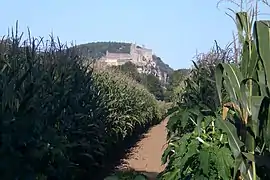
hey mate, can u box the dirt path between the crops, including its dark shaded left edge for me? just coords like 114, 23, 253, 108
94, 118, 168, 180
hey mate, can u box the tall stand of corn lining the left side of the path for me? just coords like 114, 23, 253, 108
0, 26, 165, 180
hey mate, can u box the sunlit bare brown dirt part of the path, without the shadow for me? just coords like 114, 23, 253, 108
119, 119, 168, 179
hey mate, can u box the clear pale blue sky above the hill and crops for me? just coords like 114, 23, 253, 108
0, 0, 268, 69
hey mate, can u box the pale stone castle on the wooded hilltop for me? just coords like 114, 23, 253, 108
100, 44, 168, 82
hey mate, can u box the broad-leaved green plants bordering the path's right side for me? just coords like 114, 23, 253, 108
159, 44, 234, 180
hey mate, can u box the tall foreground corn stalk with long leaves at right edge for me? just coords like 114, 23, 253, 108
216, 12, 270, 180
